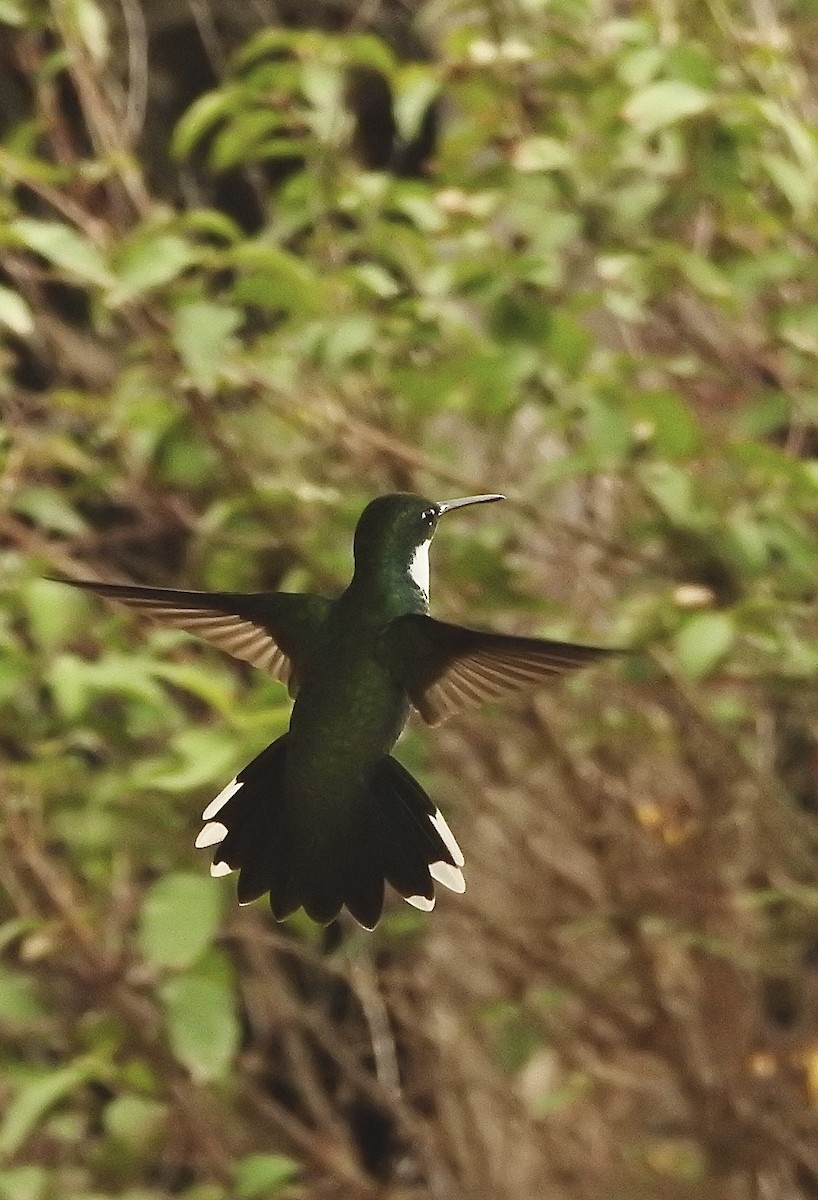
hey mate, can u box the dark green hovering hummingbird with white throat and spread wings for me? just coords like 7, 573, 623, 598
61, 492, 614, 929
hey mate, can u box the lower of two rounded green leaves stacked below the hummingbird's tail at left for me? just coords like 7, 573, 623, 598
160, 974, 240, 1082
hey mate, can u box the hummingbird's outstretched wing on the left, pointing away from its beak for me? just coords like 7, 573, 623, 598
50, 580, 332, 695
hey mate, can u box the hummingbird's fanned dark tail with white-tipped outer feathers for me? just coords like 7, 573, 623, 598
197, 734, 465, 929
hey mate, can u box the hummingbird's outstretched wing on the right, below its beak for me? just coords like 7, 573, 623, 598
385, 613, 621, 725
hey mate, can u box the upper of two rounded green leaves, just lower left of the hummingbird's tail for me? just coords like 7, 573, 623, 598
138, 871, 223, 970
